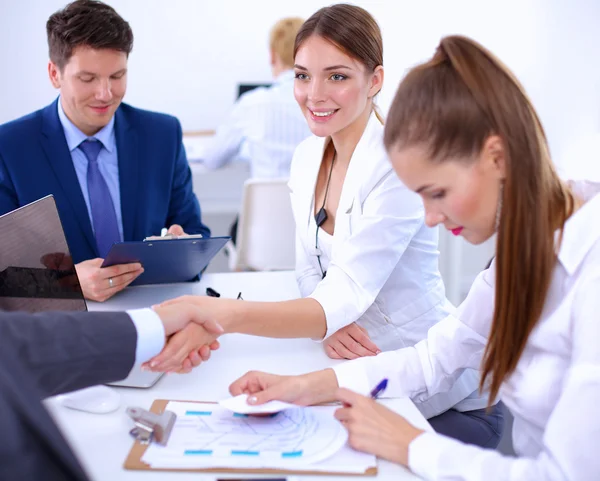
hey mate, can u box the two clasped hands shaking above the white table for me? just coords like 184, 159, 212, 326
142, 296, 231, 373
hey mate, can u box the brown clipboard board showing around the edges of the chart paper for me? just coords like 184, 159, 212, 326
123, 399, 377, 476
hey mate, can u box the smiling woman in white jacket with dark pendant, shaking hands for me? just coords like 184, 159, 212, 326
150, 4, 502, 446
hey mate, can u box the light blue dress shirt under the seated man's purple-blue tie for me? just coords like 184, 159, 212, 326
58, 98, 123, 241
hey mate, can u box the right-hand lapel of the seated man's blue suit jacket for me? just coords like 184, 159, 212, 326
115, 107, 143, 241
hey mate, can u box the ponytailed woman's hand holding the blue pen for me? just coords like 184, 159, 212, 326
335, 389, 425, 466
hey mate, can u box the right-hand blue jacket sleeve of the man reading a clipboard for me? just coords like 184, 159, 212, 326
167, 119, 210, 237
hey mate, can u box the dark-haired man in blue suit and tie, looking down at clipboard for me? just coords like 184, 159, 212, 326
0, 0, 210, 301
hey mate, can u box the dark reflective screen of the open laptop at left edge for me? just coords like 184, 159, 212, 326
0, 195, 86, 312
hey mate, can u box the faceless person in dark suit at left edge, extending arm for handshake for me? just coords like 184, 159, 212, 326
0, 303, 222, 481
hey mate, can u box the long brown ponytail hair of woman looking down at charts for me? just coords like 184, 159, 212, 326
384, 36, 573, 402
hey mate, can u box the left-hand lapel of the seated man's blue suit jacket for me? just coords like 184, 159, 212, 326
41, 99, 98, 255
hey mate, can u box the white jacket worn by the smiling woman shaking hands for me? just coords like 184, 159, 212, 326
289, 115, 487, 418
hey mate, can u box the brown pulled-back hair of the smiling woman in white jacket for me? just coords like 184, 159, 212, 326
294, 3, 383, 123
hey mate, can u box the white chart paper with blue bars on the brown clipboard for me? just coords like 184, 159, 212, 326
142, 401, 375, 470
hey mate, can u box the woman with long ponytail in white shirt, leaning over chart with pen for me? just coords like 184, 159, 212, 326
226, 36, 600, 481
